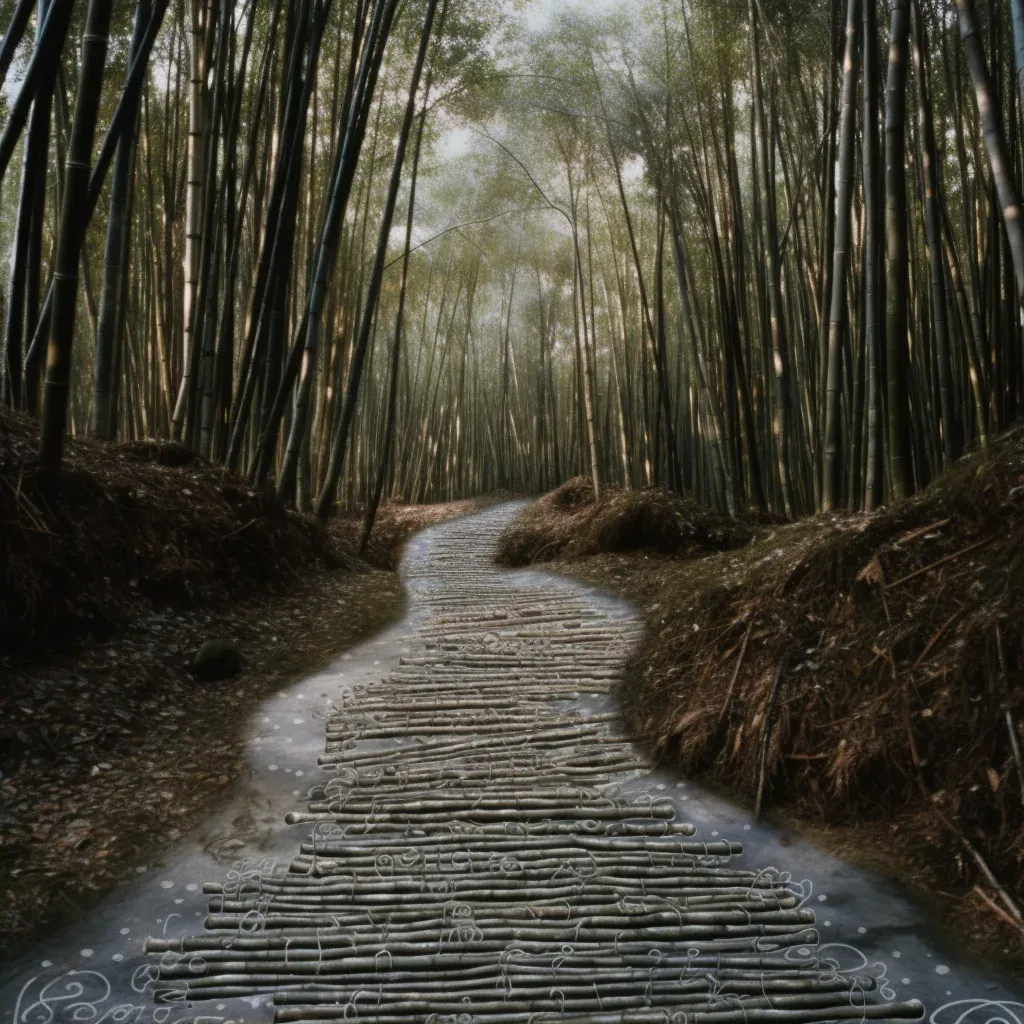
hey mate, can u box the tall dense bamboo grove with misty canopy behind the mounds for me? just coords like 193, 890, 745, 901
0, 0, 1024, 518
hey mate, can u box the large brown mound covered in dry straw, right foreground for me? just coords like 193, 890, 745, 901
629, 428, 1024, 835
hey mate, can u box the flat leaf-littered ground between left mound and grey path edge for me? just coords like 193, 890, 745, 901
0, 565, 403, 961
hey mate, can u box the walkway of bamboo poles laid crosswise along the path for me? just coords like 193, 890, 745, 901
146, 509, 923, 1024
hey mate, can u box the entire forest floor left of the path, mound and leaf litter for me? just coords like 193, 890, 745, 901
0, 413, 481, 958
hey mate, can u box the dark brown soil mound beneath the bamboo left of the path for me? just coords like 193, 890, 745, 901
0, 412, 340, 650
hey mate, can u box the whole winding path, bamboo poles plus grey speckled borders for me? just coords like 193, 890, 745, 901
0, 506, 1024, 1024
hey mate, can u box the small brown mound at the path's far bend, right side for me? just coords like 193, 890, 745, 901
499, 476, 753, 565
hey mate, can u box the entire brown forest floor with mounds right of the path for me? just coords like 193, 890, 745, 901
500, 429, 1024, 978
